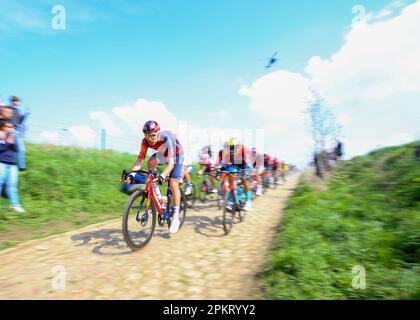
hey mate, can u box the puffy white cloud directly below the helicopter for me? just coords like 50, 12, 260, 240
239, 70, 312, 165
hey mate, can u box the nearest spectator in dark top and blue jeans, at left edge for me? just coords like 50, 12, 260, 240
0, 120, 25, 213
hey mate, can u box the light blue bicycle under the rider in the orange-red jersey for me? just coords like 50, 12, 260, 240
220, 170, 246, 235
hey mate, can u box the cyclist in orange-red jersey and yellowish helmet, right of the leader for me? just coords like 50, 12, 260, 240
218, 138, 252, 211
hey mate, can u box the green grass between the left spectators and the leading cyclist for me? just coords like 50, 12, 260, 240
0, 144, 203, 250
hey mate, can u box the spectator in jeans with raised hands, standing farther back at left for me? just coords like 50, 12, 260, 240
10, 96, 29, 171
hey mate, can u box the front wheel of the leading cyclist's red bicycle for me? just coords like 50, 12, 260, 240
122, 191, 156, 251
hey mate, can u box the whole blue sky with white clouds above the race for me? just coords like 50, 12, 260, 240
0, 0, 420, 165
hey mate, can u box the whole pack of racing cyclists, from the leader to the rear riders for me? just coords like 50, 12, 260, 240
124, 120, 289, 233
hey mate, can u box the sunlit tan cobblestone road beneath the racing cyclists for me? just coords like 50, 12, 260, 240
0, 175, 299, 299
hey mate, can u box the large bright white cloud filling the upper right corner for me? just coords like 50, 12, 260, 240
306, 2, 420, 104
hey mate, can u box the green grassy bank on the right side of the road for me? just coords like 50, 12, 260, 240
263, 142, 420, 299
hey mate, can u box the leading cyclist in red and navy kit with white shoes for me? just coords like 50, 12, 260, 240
133, 120, 184, 233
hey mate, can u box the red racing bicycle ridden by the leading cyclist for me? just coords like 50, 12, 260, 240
122, 169, 187, 251
